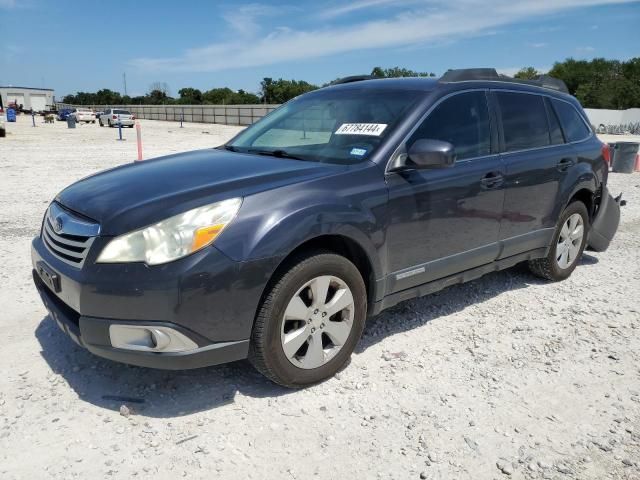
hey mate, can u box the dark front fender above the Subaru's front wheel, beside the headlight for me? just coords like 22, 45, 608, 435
216, 165, 388, 279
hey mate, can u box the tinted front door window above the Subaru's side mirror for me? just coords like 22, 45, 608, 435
407, 91, 491, 160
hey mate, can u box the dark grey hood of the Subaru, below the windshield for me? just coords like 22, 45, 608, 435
56, 149, 345, 236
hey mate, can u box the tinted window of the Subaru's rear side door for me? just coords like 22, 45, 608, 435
496, 92, 551, 152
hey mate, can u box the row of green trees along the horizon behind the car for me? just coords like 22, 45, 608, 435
62, 57, 640, 109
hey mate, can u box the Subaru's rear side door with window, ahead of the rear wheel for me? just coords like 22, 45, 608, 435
491, 90, 576, 258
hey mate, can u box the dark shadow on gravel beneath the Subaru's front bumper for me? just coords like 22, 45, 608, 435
35, 315, 293, 418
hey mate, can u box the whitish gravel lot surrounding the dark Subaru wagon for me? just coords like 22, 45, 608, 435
0, 114, 640, 480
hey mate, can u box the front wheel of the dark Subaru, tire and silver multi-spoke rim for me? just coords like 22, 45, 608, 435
249, 251, 367, 388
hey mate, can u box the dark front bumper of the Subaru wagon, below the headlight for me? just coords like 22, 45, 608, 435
31, 237, 268, 369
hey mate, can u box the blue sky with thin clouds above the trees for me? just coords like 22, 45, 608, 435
0, 0, 640, 97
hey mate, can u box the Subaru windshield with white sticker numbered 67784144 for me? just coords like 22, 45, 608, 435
225, 88, 425, 164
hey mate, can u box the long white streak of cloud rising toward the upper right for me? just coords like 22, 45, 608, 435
131, 0, 628, 72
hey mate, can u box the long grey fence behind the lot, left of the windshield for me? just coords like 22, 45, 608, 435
57, 103, 279, 125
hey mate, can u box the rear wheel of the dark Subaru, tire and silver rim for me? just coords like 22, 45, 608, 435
529, 201, 590, 282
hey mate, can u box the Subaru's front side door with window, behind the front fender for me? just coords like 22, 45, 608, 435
386, 90, 504, 294
